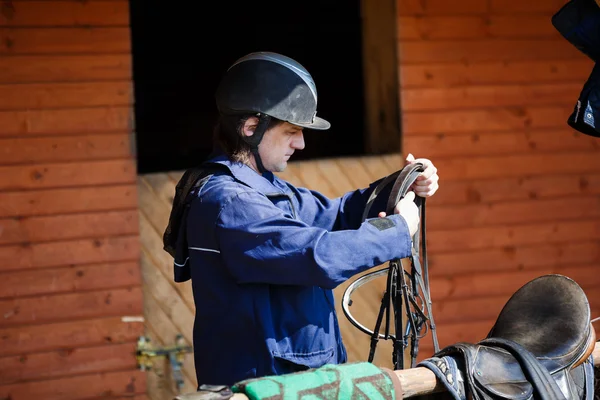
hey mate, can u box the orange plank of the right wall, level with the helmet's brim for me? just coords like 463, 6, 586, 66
402, 105, 577, 135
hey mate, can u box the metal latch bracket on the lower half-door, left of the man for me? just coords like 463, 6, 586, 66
135, 334, 194, 392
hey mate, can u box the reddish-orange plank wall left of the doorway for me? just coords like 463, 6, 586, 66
0, 0, 146, 400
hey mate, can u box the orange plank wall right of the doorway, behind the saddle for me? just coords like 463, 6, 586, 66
398, 0, 600, 358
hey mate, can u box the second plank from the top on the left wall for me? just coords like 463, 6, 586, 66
0, 27, 131, 56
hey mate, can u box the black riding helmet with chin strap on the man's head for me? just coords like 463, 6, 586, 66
215, 52, 331, 172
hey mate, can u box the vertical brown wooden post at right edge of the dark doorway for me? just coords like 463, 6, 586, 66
361, 0, 401, 154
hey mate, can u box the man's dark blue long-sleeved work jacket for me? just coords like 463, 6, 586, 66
175, 152, 411, 385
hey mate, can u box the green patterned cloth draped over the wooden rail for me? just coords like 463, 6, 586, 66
232, 362, 401, 400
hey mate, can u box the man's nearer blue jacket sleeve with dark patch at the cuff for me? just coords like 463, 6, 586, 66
216, 192, 411, 289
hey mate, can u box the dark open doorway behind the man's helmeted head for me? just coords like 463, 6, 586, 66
130, 0, 365, 173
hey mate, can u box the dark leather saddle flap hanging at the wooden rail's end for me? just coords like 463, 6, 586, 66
471, 346, 533, 400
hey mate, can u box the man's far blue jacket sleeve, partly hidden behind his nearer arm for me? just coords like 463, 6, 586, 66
291, 178, 393, 231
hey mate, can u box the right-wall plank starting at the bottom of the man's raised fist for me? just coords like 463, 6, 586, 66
420, 170, 600, 205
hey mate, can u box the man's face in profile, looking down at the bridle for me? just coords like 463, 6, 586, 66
258, 122, 304, 172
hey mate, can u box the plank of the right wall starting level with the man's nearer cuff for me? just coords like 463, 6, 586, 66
427, 217, 600, 252
